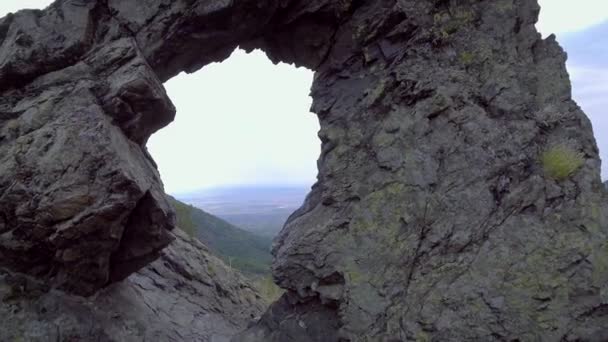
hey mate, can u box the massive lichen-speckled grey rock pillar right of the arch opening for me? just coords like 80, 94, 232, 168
245, 1, 608, 341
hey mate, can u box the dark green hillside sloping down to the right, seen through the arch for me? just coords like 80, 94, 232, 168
171, 198, 272, 276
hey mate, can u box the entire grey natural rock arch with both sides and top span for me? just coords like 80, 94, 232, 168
0, 0, 608, 342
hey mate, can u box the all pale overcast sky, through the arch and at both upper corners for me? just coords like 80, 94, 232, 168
0, 0, 608, 193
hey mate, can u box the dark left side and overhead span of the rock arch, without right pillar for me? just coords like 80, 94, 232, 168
0, 0, 349, 295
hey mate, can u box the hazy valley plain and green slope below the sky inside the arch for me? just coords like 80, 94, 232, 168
170, 187, 308, 302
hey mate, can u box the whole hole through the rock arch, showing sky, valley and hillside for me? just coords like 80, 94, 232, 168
146, 49, 320, 280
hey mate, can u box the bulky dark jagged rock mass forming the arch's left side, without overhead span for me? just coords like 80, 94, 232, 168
0, 1, 174, 295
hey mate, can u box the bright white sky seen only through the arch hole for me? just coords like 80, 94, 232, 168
147, 49, 320, 198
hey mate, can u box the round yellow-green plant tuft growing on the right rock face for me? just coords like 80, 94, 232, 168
542, 145, 585, 181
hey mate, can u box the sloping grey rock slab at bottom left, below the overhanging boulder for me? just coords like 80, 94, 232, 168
0, 230, 264, 342
